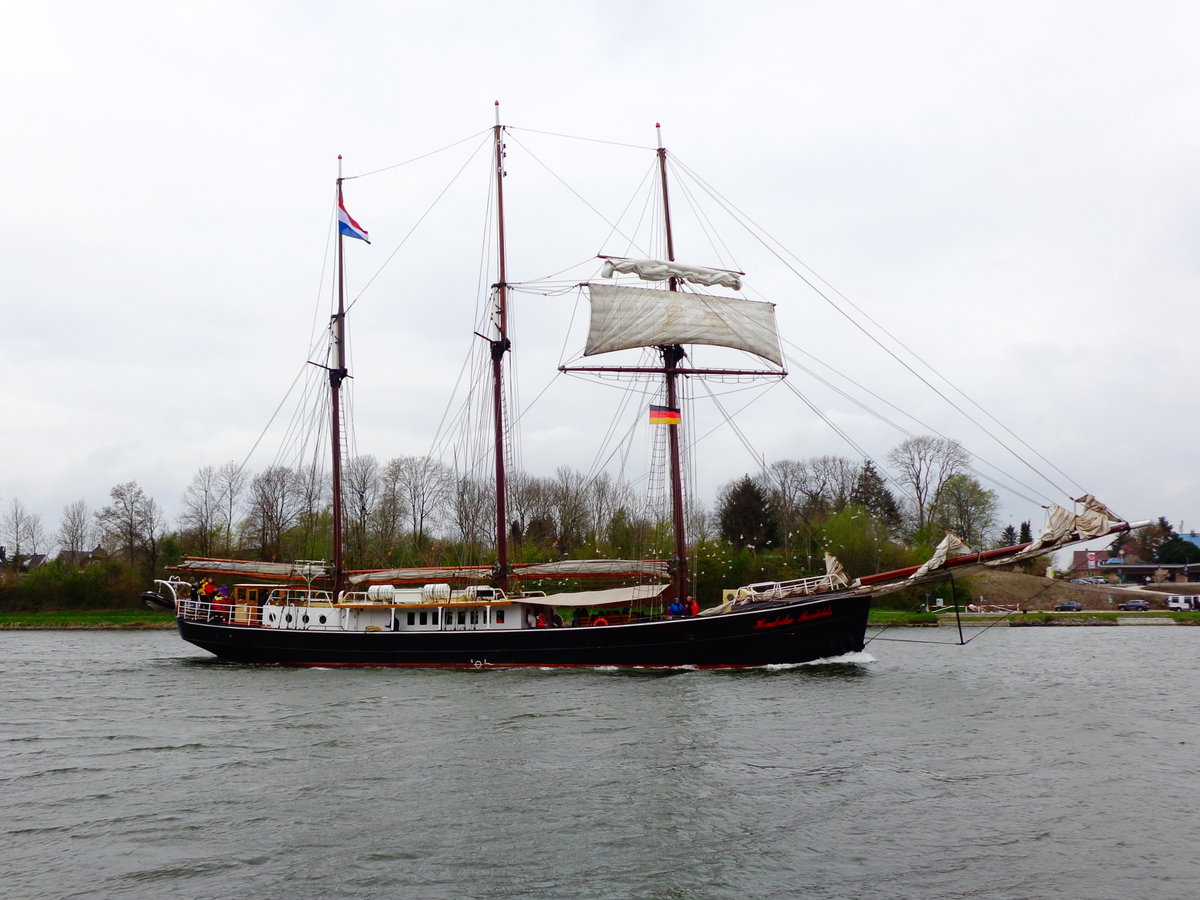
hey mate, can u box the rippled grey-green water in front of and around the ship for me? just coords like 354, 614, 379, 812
0, 628, 1200, 900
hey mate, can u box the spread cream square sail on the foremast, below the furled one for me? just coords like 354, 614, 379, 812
583, 284, 784, 366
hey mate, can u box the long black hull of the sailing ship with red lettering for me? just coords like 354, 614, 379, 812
178, 596, 870, 668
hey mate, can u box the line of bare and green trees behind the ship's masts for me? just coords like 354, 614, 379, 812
0, 436, 1028, 609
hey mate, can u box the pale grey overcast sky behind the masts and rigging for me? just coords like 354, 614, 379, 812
0, 0, 1200, 549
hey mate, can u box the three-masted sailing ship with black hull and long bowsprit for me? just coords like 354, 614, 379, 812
144, 106, 1136, 667
